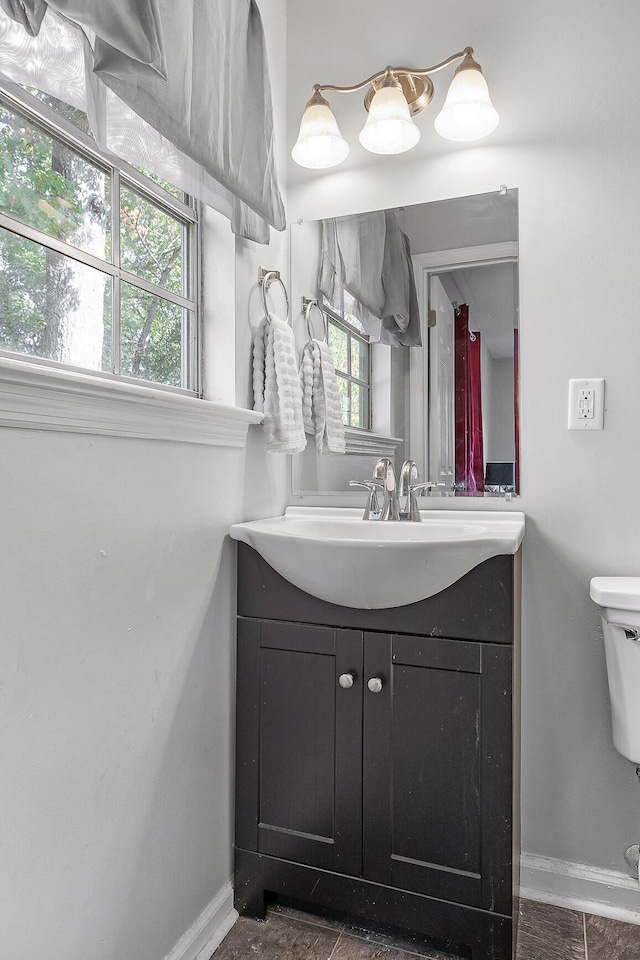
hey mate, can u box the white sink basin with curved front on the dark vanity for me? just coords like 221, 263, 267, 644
230, 507, 524, 610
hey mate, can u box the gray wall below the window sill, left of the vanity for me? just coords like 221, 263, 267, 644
0, 429, 243, 960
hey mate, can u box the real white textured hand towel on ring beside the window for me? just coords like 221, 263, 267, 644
253, 314, 307, 453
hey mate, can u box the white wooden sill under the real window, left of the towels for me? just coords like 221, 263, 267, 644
0, 357, 262, 447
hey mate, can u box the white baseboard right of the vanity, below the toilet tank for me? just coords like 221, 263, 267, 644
520, 853, 640, 924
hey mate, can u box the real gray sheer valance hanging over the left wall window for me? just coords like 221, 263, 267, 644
0, 0, 285, 243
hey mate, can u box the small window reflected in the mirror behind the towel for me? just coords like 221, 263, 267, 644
324, 298, 371, 430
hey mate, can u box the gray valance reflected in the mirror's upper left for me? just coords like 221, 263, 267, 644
318, 210, 422, 347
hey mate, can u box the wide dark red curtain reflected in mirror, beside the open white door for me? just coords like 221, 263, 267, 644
455, 303, 484, 493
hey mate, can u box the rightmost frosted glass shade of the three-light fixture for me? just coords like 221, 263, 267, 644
434, 67, 500, 140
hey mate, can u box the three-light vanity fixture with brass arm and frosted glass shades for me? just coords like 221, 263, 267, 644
291, 47, 499, 170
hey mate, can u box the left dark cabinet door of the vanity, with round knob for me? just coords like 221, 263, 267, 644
236, 620, 362, 874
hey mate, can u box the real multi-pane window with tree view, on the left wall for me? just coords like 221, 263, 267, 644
0, 85, 199, 394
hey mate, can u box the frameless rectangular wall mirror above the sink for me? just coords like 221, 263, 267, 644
291, 187, 520, 498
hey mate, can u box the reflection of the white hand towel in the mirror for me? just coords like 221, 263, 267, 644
300, 340, 345, 455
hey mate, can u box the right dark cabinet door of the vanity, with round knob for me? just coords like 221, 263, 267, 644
363, 633, 512, 912
